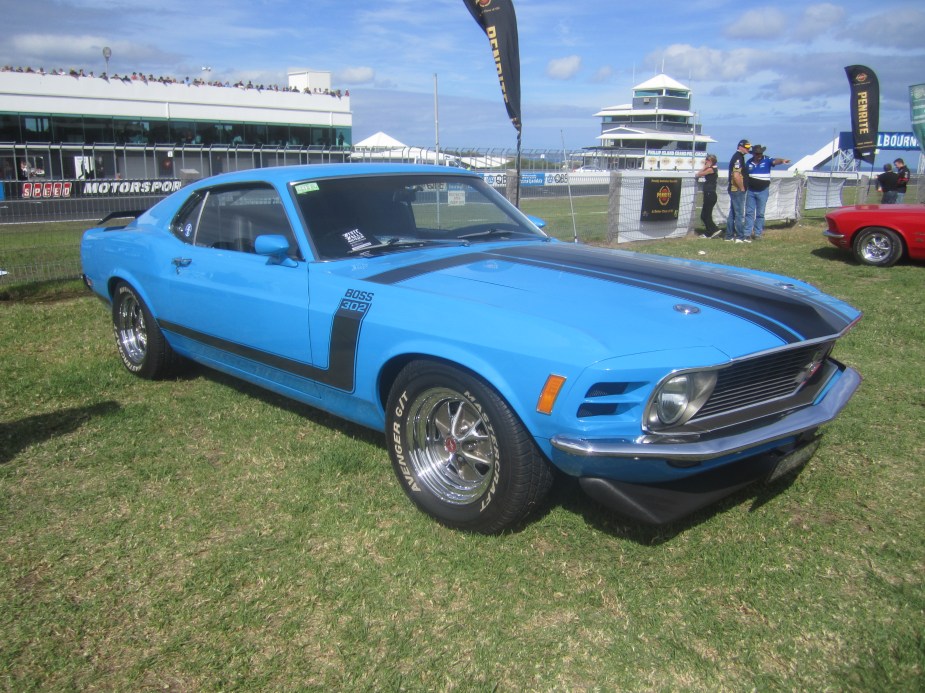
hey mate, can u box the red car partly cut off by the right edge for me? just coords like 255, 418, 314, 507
823, 205, 925, 267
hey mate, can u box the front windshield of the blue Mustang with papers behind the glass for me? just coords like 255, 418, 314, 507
292, 174, 547, 259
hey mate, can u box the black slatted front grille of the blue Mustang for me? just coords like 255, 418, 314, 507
692, 344, 832, 421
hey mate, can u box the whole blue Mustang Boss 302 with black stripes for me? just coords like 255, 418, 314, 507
81, 164, 860, 532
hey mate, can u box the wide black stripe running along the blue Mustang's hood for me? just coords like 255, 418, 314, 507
370, 243, 851, 344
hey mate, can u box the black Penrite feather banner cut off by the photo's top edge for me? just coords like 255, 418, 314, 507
463, 0, 521, 132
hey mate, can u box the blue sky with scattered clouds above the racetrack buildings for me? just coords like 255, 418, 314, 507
0, 0, 925, 162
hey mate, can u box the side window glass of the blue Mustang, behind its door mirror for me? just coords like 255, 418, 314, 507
171, 184, 301, 259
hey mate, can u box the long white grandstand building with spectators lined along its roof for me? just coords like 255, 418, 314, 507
0, 68, 353, 180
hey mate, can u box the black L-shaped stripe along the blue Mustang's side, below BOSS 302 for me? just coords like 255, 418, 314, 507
158, 306, 367, 392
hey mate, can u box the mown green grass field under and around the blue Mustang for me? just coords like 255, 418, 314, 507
0, 221, 925, 691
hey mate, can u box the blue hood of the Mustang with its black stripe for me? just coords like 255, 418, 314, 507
356, 242, 860, 358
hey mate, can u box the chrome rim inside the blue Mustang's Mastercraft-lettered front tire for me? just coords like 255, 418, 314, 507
405, 388, 496, 505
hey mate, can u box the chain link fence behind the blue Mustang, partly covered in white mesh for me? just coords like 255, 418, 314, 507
0, 144, 920, 285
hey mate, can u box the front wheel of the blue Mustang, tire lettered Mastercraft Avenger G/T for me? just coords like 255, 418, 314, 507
386, 361, 553, 534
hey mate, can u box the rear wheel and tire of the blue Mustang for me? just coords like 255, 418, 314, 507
112, 282, 177, 380
